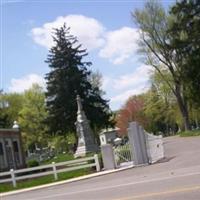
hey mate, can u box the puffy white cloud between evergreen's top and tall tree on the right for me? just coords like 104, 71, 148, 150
99, 27, 139, 64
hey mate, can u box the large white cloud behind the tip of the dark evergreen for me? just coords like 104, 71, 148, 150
32, 15, 104, 50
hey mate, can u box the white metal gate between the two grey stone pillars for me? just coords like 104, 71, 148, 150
113, 142, 133, 167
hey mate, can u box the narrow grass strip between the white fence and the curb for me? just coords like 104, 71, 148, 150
0, 168, 94, 193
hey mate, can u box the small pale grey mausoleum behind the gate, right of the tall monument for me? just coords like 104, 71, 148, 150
99, 129, 118, 145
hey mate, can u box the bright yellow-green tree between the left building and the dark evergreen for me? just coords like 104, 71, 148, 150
19, 84, 47, 149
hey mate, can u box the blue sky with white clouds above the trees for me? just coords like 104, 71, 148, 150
0, 0, 174, 110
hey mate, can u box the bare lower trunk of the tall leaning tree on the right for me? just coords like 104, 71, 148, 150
175, 83, 191, 130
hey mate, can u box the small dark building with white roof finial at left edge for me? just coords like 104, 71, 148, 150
0, 122, 25, 171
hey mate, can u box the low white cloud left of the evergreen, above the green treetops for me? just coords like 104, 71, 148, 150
9, 74, 45, 93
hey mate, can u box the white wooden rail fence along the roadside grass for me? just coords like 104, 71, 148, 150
0, 154, 100, 187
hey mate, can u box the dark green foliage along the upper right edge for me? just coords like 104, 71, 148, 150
168, 0, 200, 105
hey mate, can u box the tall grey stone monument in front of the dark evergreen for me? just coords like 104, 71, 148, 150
74, 95, 99, 158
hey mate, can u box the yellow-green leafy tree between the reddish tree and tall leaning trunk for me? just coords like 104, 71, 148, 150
144, 71, 183, 135
